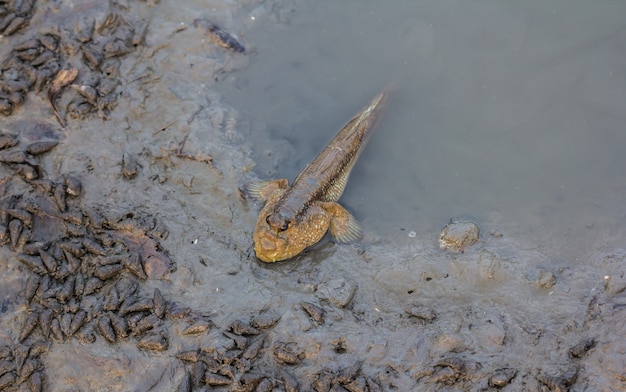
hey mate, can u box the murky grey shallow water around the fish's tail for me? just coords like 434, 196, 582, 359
224, 1, 626, 261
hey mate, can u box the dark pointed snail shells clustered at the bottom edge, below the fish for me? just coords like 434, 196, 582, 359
176, 312, 382, 392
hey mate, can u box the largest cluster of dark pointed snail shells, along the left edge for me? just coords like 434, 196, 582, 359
0, 125, 174, 390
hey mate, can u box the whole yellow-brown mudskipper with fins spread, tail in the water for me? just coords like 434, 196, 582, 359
247, 91, 388, 263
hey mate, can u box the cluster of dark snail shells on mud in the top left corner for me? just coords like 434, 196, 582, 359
0, 0, 147, 124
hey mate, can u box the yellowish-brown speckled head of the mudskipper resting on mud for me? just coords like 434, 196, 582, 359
254, 203, 330, 263
